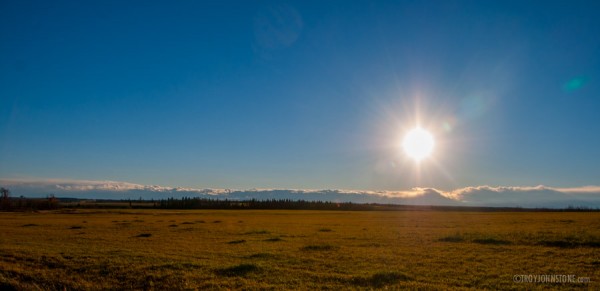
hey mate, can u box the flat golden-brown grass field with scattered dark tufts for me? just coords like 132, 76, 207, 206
0, 210, 600, 290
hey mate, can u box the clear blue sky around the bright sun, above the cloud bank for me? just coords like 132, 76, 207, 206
0, 0, 600, 190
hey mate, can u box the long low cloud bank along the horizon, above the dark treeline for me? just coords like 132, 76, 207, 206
0, 179, 600, 208
